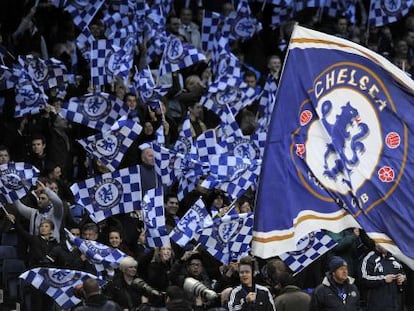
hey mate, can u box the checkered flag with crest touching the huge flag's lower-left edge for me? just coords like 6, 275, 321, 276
197, 213, 253, 264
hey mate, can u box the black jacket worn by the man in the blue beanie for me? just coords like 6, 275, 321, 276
310, 274, 359, 311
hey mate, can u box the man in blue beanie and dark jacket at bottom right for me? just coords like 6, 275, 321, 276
310, 256, 360, 311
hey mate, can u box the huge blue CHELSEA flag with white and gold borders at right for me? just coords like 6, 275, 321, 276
253, 26, 414, 266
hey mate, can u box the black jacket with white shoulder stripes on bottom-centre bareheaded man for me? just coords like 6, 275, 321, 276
228, 284, 276, 311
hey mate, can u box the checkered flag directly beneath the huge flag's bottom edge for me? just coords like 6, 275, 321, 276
279, 231, 337, 274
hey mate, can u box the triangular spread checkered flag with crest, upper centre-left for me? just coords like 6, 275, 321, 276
159, 35, 206, 76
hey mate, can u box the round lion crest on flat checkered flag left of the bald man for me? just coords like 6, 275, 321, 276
92, 178, 123, 210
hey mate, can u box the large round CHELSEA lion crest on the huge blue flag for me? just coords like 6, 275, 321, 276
291, 62, 406, 216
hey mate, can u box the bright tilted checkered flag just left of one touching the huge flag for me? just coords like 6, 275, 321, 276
170, 198, 213, 247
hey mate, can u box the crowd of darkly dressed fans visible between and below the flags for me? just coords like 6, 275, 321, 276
0, 0, 414, 311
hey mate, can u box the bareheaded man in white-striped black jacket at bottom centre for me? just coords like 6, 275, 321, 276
228, 256, 276, 311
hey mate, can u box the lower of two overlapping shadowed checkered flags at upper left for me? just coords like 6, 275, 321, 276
13, 70, 48, 118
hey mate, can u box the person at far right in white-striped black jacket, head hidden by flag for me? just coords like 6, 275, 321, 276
361, 244, 407, 311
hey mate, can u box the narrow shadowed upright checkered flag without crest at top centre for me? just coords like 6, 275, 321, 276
201, 10, 224, 52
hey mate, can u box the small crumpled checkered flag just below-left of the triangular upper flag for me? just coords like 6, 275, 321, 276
134, 68, 171, 109
